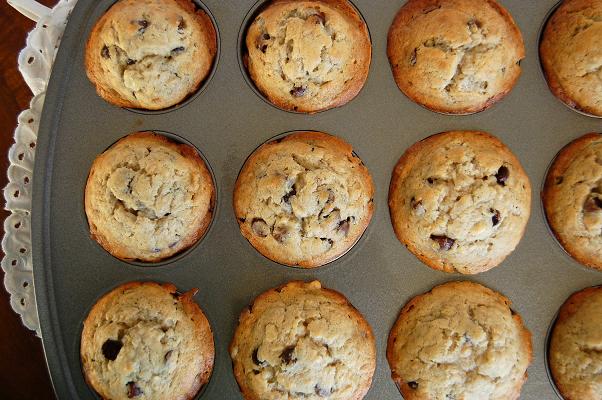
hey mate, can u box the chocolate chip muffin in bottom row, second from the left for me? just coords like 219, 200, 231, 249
230, 281, 376, 400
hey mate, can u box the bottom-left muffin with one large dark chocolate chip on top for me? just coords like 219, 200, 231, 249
80, 282, 215, 400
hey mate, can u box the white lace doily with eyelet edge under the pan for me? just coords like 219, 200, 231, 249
1, 0, 77, 336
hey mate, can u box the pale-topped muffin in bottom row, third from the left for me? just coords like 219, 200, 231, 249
387, 282, 532, 400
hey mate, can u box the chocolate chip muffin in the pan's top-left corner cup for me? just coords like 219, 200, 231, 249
85, 0, 217, 110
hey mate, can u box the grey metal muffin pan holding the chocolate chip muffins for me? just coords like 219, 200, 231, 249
32, 0, 602, 400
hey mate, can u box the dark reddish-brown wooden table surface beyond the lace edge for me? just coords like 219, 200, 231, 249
0, 0, 57, 400
